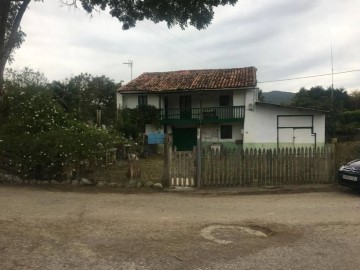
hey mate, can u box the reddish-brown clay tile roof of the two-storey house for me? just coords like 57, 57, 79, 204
118, 67, 257, 93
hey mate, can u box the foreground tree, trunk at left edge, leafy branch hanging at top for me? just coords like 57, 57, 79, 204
0, 0, 237, 97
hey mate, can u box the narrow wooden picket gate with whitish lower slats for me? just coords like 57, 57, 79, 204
168, 150, 196, 187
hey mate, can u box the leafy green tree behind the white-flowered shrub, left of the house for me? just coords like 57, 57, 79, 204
50, 73, 118, 124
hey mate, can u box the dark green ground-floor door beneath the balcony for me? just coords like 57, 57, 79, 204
173, 128, 197, 151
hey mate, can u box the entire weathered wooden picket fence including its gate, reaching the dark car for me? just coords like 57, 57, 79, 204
164, 142, 360, 187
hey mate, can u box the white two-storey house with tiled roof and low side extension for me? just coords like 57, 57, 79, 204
117, 67, 325, 150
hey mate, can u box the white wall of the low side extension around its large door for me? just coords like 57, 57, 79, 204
244, 104, 325, 148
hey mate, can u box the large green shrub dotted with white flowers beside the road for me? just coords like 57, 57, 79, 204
0, 85, 123, 179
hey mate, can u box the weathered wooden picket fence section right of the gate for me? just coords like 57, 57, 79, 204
201, 146, 334, 187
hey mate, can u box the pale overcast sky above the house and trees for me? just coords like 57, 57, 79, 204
8, 0, 360, 92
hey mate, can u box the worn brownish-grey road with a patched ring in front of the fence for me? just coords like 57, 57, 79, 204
0, 186, 360, 270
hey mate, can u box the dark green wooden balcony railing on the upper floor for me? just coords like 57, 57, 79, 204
160, 106, 245, 125
